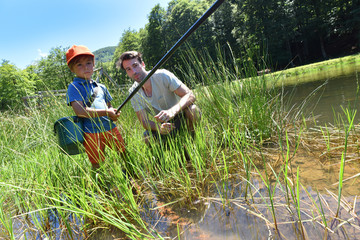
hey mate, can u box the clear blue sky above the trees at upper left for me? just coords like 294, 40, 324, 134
0, 0, 170, 69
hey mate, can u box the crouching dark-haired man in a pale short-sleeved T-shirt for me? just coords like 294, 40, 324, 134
117, 51, 201, 144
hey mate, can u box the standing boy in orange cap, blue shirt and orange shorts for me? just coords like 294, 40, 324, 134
66, 45, 125, 169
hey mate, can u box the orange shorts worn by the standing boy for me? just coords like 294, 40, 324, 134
84, 127, 125, 164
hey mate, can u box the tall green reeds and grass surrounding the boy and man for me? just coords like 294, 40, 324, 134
0, 44, 353, 239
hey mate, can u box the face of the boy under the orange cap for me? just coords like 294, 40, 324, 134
71, 55, 94, 80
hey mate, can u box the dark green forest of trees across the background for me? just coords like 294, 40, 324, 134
0, 0, 360, 110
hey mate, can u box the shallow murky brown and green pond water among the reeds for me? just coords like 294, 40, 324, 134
0, 66, 360, 240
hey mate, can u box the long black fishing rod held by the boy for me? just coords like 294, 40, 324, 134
116, 0, 224, 113
